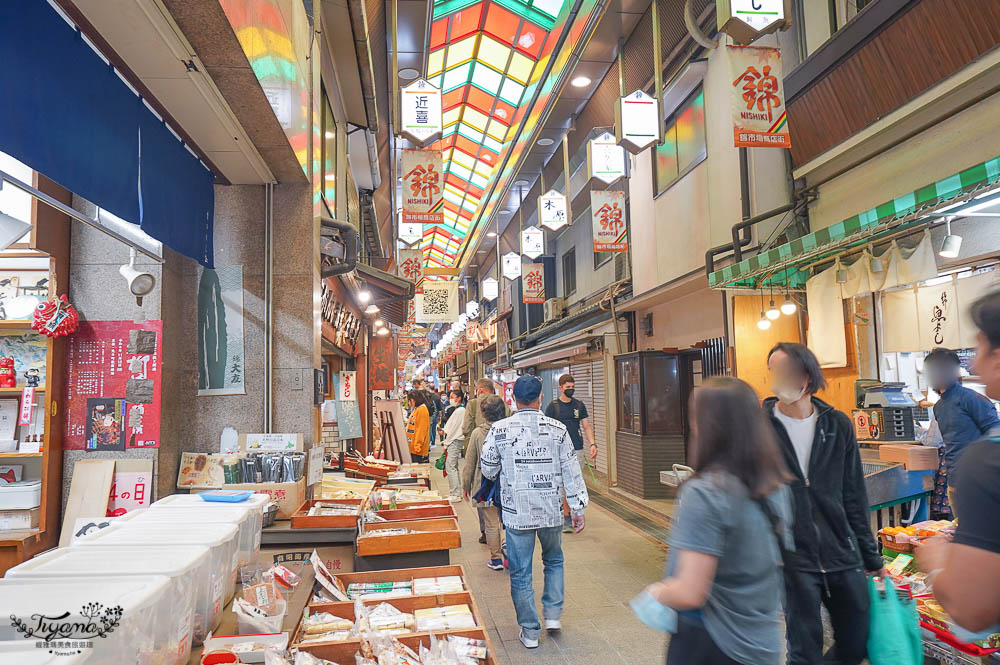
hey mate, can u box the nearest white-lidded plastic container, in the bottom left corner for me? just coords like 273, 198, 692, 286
0, 575, 168, 665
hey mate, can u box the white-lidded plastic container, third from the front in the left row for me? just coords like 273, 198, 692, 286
71, 522, 239, 630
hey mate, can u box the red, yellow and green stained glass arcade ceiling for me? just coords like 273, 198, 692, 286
421, 0, 568, 267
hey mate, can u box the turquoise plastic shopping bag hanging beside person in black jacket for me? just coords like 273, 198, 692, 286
868, 577, 924, 665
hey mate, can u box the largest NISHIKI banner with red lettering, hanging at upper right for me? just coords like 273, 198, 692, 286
726, 46, 792, 148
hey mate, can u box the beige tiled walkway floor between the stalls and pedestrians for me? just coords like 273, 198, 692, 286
432, 449, 665, 665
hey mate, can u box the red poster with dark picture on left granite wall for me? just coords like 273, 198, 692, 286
63, 321, 163, 450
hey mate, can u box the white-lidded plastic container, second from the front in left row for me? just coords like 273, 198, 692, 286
6, 545, 212, 665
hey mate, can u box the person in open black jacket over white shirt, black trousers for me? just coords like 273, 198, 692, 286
764, 342, 883, 665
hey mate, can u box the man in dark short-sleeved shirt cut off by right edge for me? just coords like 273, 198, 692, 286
917, 291, 1000, 633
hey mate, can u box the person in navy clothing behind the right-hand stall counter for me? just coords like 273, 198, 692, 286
924, 348, 1000, 517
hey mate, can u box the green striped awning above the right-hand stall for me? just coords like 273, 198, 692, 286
708, 157, 1000, 289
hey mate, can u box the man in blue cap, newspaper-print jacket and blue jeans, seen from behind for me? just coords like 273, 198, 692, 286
480, 376, 588, 649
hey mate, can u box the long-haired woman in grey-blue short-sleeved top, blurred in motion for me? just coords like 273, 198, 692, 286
646, 377, 792, 665
